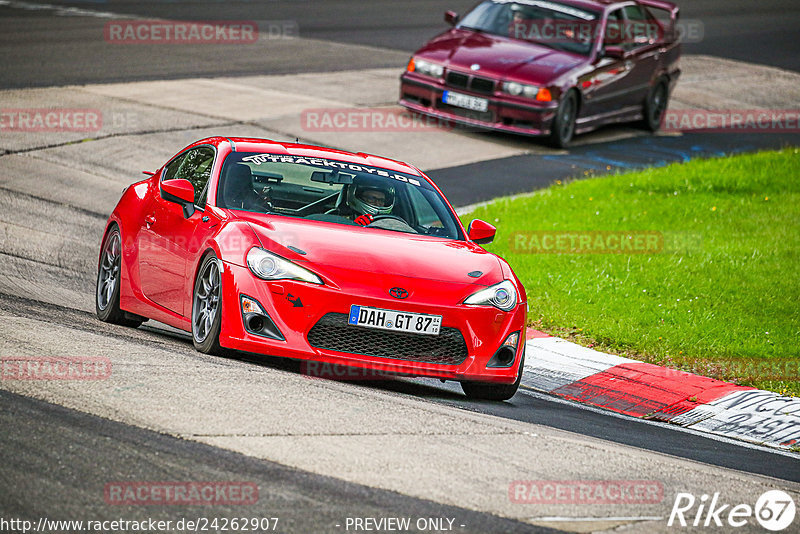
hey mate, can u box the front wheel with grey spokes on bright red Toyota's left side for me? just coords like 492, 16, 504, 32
192, 252, 225, 356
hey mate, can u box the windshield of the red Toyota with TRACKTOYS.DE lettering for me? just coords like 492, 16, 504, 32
217, 152, 463, 239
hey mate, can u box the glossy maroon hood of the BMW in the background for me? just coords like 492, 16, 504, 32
416, 29, 588, 85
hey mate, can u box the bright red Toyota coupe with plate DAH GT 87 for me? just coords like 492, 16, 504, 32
96, 137, 527, 400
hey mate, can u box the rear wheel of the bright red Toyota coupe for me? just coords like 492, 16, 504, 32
94, 224, 145, 328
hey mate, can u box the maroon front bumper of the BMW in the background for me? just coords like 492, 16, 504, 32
398, 72, 558, 136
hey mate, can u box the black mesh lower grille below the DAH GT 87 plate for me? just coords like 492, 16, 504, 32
308, 313, 467, 365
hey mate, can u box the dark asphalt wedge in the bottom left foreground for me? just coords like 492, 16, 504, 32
0, 390, 556, 534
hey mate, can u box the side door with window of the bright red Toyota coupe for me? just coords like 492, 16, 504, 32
139, 146, 216, 316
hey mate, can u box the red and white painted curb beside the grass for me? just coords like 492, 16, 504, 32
523, 329, 800, 449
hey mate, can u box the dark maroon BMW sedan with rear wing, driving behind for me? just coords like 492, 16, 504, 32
400, 0, 680, 147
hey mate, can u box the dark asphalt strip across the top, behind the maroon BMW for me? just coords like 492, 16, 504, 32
0, 0, 800, 90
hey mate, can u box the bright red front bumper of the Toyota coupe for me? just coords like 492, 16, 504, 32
220, 263, 526, 383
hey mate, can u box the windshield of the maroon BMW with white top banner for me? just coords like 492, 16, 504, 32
458, 0, 600, 56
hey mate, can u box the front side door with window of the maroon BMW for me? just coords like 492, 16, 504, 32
578, 8, 635, 117
